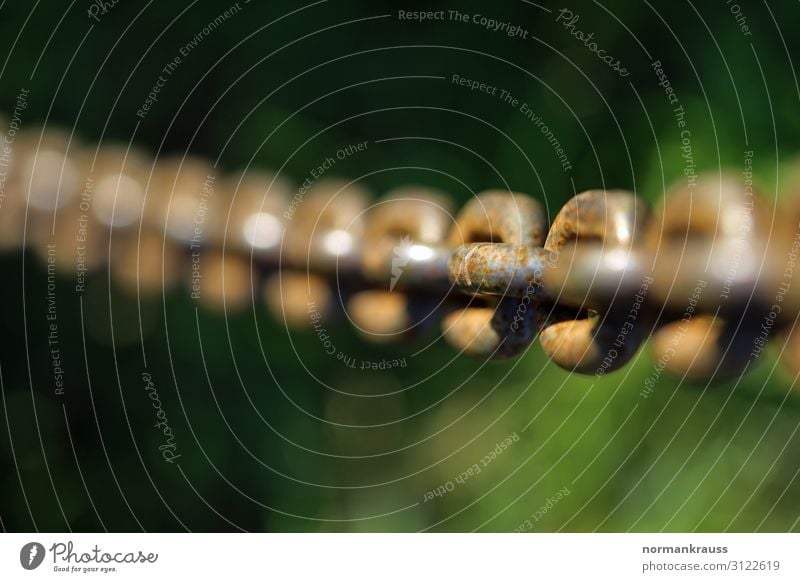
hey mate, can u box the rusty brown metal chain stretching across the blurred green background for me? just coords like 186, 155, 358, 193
0, 121, 800, 382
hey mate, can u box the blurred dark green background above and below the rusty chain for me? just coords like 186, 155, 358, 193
0, 0, 800, 531
